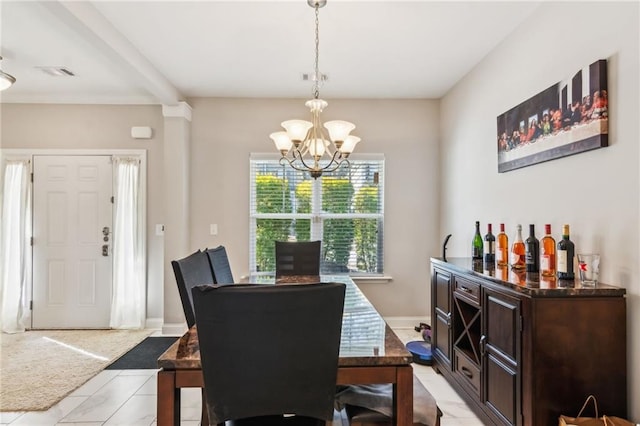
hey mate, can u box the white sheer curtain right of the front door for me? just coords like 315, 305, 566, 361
110, 158, 146, 329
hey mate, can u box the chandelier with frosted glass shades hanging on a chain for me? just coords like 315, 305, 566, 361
269, 0, 360, 179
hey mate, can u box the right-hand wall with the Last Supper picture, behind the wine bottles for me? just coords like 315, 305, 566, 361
440, 2, 640, 421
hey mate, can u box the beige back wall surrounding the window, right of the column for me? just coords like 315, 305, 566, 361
189, 98, 440, 316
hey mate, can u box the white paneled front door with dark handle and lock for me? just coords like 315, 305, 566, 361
31, 155, 113, 328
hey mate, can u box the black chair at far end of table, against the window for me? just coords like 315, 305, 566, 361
276, 241, 320, 278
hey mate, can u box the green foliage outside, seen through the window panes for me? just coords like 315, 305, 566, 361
255, 169, 380, 273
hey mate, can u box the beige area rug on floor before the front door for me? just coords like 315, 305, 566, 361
0, 330, 152, 411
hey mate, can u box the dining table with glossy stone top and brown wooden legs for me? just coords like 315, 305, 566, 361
157, 274, 413, 426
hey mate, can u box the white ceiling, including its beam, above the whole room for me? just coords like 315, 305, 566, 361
0, 0, 540, 105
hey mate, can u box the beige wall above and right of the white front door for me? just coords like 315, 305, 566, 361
0, 104, 164, 318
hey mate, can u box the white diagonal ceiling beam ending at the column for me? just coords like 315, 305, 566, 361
42, 1, 184, 105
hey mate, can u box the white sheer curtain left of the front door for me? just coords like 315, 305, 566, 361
0, 160, 31, 333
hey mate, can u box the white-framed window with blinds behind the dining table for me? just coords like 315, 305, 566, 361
250, 155, 384, 275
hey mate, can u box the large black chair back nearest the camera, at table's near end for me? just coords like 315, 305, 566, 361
192, 283, 345, 426
